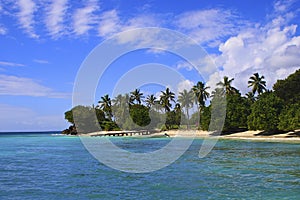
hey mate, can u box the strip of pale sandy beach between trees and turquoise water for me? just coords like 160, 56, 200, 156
78, 130, 300, 143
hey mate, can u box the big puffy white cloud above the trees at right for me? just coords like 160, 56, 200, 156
216, 11, 300, 93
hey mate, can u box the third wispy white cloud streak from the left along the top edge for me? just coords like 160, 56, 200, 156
73, 1, 99, 35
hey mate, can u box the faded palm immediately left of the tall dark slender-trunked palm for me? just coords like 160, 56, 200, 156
178, 89, 194, 129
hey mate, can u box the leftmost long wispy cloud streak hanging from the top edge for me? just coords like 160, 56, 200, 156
17, 0, 38, 38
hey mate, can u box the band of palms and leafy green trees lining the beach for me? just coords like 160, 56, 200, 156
65, 70, 300, 133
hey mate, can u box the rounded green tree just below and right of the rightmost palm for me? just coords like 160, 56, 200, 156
248, 92, 283, 131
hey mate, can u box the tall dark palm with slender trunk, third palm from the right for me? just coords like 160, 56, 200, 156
192, 81, 209, 128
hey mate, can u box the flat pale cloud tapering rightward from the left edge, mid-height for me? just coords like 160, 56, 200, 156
0, 75, 70, 98
